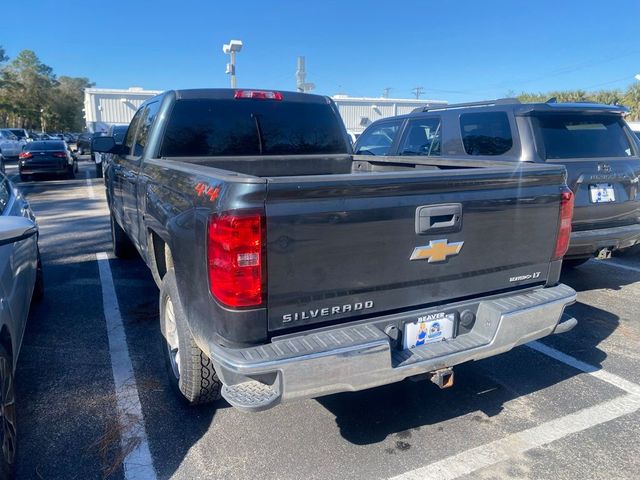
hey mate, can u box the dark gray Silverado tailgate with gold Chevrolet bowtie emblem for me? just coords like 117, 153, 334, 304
265, 164, 565, 332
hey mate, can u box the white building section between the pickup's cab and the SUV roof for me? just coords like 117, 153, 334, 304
331, 95, 447, 134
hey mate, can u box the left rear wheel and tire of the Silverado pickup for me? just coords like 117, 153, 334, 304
160, 269, 222, 405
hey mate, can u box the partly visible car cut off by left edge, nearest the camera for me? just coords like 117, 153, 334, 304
0, 175, 44, 479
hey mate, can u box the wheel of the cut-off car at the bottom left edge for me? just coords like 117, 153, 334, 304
0, 345, 17, 479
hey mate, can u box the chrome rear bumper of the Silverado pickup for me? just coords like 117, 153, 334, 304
210, 284, 576, 411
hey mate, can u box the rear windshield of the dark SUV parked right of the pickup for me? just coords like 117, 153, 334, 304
534, 113, 633, 159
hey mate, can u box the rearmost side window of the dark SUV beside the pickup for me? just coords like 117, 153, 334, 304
460, 112, 513, 155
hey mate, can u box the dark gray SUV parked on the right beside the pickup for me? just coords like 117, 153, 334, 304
355, 99, 640, 266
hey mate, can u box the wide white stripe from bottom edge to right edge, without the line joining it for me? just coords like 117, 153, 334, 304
392, 395, 640, 480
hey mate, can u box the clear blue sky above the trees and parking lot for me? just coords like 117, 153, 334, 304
5, 0, 640, 101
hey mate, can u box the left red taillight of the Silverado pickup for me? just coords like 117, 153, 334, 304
207, 211, 266, 307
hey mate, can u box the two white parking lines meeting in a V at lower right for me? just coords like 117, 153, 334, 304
391, 342, 640, 480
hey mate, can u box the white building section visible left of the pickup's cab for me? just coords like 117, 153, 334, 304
84, 87, 162, 132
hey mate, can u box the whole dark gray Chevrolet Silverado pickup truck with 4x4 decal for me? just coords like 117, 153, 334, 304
92, 89, 576, 411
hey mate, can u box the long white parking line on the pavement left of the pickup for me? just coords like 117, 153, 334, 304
96, 252, 156, 480
